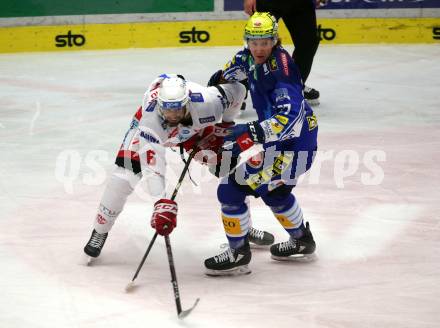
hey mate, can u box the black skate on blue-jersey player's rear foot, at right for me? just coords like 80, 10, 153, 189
270, 222, 316, 261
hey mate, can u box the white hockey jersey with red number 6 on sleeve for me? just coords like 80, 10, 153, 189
118, 76, 246, 195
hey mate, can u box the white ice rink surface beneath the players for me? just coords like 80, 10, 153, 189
0, 45, 440, 328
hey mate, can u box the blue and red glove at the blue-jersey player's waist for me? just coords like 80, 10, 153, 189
222, 121, 264, 156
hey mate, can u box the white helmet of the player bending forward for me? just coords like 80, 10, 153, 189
157, 74, 189, 110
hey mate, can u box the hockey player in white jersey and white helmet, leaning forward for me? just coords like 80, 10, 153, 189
84, 74, 274, 258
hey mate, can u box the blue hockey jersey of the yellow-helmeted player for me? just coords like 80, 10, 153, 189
223, 46, 318, 151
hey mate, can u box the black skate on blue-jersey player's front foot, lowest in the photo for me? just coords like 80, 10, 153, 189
205, 242, 252, 276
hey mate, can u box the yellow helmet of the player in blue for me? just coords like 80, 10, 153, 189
244, 12, 278, 42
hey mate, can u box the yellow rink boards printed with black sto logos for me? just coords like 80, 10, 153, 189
0, 18, 440, 53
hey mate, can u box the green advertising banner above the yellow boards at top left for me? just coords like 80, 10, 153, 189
0, 0, 214, 18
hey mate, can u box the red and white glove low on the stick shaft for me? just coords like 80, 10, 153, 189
151, 198, 177, 236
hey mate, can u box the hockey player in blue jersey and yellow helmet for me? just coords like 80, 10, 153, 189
205, 12, 318, 276
